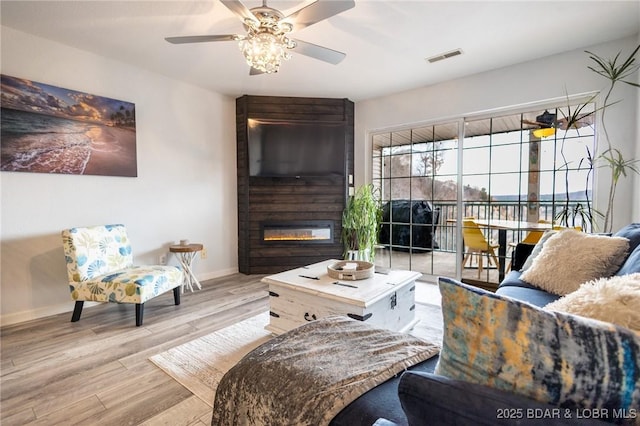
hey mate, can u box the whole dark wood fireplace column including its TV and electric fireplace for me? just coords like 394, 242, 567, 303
236, 95, 354, 274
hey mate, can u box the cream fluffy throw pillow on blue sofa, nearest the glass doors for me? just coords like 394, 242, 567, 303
520, 229, 629, 296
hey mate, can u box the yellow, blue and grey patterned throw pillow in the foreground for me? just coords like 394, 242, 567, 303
435, 278, 640, 420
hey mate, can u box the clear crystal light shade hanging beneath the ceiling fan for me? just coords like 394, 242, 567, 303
239, 32, 291, 73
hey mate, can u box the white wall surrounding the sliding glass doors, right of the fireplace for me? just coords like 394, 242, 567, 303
355, 36, 640, 230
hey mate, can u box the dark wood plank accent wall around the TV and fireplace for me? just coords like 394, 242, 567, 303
236, 95, 354, 274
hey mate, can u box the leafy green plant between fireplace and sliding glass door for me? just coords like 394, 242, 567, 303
341, 184, 382, 262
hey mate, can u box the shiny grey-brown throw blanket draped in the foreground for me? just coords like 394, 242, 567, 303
211, 316, 440, 426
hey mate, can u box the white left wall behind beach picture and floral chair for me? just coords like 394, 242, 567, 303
0, 27, 237, 325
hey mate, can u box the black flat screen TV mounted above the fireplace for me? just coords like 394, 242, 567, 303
248, 119, 345, 177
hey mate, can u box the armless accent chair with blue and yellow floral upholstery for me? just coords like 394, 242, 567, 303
62, 224, 182, 326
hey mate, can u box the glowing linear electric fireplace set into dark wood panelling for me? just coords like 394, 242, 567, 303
260, 220, 333, 244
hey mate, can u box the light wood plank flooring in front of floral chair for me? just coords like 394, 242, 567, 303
0, 274, 269, 426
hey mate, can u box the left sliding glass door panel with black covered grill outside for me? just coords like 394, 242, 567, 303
373, 122, 460, 275
